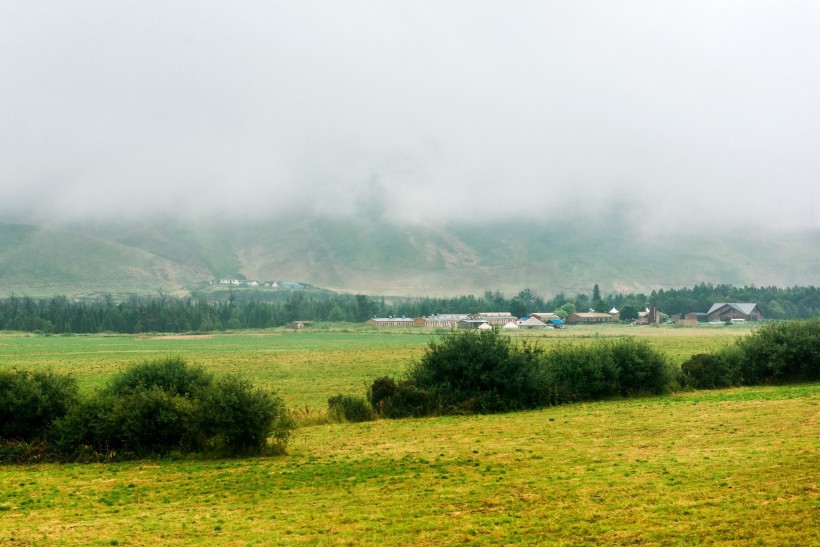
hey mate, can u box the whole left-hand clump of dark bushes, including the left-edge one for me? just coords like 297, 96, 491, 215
0, 357, 294, 462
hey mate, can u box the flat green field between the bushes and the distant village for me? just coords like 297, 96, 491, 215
0, 325, 750, 408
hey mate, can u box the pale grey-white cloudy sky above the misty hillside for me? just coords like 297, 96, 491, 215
0, 0, 820, 228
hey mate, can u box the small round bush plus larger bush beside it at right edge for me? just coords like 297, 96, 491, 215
681, 319, 820, 389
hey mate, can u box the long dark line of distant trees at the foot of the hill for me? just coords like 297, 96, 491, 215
0, 283, 820, 334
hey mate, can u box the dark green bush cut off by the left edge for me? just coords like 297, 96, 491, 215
0, 370, 79, 442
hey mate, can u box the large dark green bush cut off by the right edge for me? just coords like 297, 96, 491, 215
738, 318, 820, 385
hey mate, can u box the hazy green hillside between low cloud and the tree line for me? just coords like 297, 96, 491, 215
0, 217, 820, 297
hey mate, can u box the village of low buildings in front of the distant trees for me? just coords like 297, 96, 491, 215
367, 302, 764, 330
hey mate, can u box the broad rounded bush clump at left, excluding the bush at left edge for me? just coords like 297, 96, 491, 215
54, 358, 293, 460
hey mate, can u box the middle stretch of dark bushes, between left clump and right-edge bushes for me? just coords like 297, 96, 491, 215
368, 330, 677, 417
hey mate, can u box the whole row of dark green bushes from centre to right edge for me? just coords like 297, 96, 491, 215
362, 319, 820, 418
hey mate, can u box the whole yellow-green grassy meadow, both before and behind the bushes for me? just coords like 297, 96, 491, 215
0, 326, 820, 545
